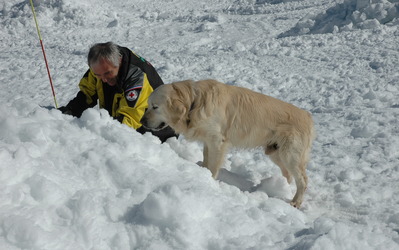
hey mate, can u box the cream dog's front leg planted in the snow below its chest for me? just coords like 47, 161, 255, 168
204, 141, 227, 179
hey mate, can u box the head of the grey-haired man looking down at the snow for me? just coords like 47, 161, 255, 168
87, 42, 122, 86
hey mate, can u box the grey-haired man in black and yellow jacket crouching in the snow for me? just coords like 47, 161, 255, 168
59, 42, 176, 142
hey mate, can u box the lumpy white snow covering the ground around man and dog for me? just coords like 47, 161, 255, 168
0, 0, 399, 250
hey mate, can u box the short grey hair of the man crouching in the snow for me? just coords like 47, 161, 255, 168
87, 42, 122, 67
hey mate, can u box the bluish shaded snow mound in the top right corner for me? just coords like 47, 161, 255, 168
279, 0, 399, 38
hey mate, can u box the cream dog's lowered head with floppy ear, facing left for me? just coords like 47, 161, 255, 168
140, 81, 193, 133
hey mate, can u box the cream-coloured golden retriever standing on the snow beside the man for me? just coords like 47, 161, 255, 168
141, 80, 314, 208
